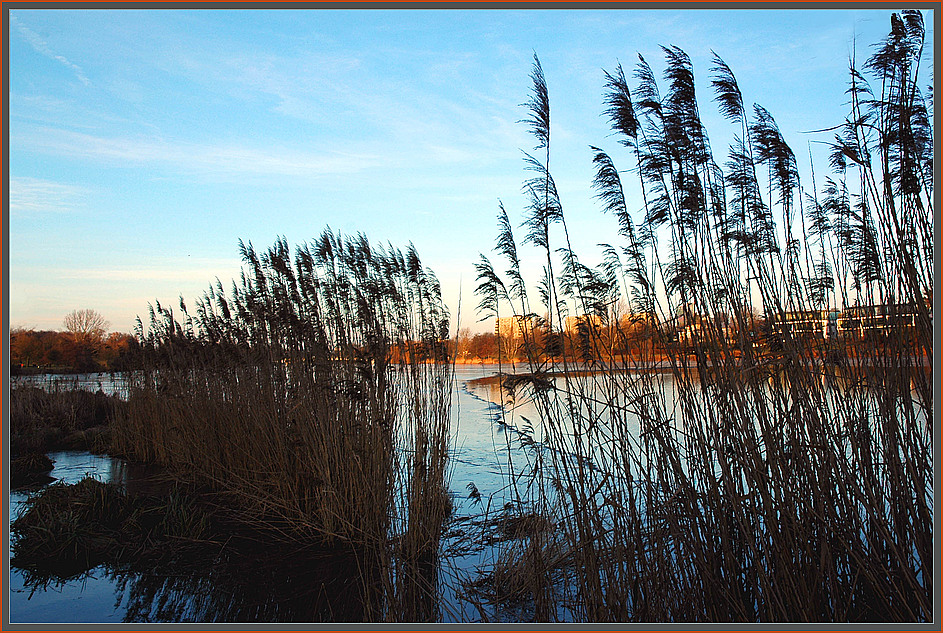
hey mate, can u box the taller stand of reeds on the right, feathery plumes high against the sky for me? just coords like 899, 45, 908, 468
477, 11, 933, 621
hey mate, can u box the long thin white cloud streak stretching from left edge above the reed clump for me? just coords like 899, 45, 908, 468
10, 126, 381, 177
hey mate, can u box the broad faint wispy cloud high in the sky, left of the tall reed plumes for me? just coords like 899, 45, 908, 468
165, 41, 518, 162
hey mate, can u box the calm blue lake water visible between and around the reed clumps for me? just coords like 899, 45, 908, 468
8, 365, 925, 624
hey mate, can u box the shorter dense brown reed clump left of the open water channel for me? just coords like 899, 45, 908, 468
115, 231, 451, 620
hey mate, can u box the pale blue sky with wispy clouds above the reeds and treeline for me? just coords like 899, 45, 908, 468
5, 8, 934, 332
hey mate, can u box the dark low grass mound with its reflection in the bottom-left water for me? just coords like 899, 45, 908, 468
11, 475, 370, 622
